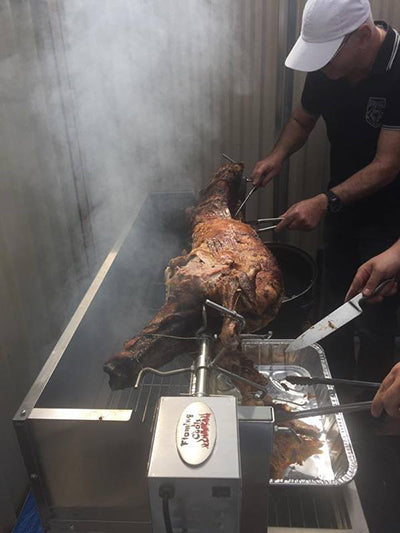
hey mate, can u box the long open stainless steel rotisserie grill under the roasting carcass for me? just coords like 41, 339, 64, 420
14, 194, 367, 533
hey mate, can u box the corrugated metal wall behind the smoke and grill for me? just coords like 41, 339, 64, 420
0, 0, 400, 531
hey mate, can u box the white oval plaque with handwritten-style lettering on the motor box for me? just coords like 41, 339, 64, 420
176, 402, 217, 466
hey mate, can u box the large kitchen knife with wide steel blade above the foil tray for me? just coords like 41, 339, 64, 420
285, 278, 394, 353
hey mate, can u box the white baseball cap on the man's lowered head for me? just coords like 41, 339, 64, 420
285, 0, 371, 72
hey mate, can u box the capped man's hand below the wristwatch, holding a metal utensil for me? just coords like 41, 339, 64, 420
276, 194, 328, 231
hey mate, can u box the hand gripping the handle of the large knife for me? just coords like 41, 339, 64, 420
346, 241, 400, 303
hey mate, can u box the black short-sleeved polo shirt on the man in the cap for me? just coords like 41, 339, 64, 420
301, 21, 400, 220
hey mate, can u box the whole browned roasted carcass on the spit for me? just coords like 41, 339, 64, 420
104, 164, 283, 389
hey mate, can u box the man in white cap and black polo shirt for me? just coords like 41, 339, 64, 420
253, 0, 400, 381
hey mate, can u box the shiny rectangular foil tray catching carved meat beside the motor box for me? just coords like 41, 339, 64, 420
231, 338, 357, 487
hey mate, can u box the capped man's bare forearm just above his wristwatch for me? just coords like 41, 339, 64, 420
332, 161, 398, 204
